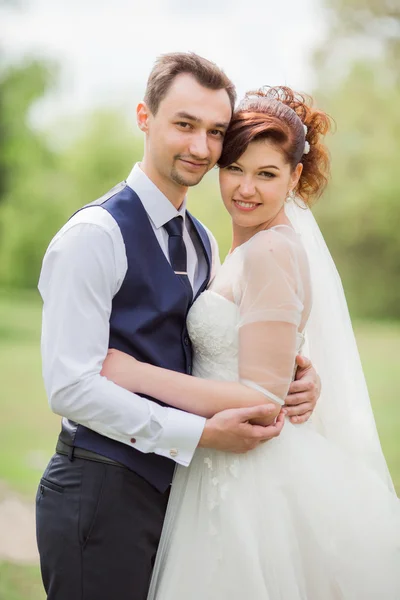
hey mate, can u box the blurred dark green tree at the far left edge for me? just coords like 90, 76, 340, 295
0, 61, 60, 284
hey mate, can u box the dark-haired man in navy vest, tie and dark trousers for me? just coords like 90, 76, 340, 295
36, 53, 318, 600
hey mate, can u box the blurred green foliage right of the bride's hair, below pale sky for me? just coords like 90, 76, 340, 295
315, 63, 400, 318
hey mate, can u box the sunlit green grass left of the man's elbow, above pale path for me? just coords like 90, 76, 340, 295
0, 293, 60, 496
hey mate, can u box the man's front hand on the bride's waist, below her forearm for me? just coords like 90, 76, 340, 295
199, 405, 285, 454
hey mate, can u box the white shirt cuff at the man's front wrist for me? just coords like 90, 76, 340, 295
154, 408, 206, 467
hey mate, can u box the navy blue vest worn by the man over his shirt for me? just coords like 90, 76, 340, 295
60, 182, 211, 492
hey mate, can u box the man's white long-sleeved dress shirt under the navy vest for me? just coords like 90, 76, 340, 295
39, 165, 220, 466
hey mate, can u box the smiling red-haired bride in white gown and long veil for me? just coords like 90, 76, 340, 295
103, 88, 400, 600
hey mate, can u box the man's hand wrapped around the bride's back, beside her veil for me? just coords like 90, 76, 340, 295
285, 355, 321, 423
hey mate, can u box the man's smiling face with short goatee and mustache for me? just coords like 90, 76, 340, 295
141, 73, 232, 187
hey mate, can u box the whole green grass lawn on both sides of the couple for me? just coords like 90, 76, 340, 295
0, 292, 400, 600
